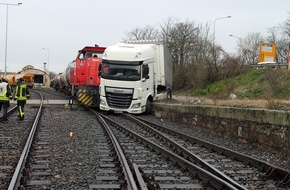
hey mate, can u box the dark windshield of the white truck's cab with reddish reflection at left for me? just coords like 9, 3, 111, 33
101, 63, 141, 81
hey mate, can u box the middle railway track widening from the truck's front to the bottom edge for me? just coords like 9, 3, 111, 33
90, 110, 237, 189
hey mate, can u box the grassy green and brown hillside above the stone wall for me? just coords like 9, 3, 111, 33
172, 67, 290, 110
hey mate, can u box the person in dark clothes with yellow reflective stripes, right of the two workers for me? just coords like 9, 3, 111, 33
14, 78, 30, 120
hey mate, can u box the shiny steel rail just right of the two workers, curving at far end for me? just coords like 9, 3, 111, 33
8, 91, 44, 190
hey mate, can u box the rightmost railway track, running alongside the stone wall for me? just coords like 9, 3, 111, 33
107, 115, 290, 189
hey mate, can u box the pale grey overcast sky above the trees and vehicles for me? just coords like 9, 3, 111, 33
0, 0, 290, 73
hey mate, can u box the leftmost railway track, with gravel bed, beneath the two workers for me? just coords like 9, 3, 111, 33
0, 90, 42, 189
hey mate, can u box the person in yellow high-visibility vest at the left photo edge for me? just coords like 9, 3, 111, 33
0, 78, 12, 121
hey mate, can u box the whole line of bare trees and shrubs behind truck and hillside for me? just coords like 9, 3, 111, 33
123, 16, 290, 90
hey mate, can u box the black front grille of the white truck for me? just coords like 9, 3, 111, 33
106, 87, 133, 109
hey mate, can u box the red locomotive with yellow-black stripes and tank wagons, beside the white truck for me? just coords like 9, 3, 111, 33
50, 45, 106, 108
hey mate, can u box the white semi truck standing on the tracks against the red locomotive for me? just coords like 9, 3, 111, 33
99, 40, 172, 114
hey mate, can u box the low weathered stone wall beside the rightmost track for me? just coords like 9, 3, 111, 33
153, 103, 290, 157
